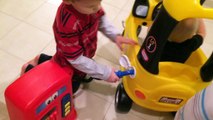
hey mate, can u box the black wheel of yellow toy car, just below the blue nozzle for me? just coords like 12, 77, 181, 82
115, 83, 132, 113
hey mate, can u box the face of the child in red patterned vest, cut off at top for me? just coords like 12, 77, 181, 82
72, 0, 101, 14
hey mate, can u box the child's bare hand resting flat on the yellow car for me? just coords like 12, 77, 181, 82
115, 35, 138, 51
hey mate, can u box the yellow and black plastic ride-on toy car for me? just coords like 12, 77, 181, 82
115, 0, 213, 113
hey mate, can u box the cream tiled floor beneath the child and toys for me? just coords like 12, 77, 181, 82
0, 0, 213, 120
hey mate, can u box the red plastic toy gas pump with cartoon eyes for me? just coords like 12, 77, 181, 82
5, 61, 77, 120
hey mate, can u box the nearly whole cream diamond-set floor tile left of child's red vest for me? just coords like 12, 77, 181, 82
0, 23, 53, 60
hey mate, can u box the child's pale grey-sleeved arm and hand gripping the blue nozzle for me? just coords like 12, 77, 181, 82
68, 55, 119, 82
